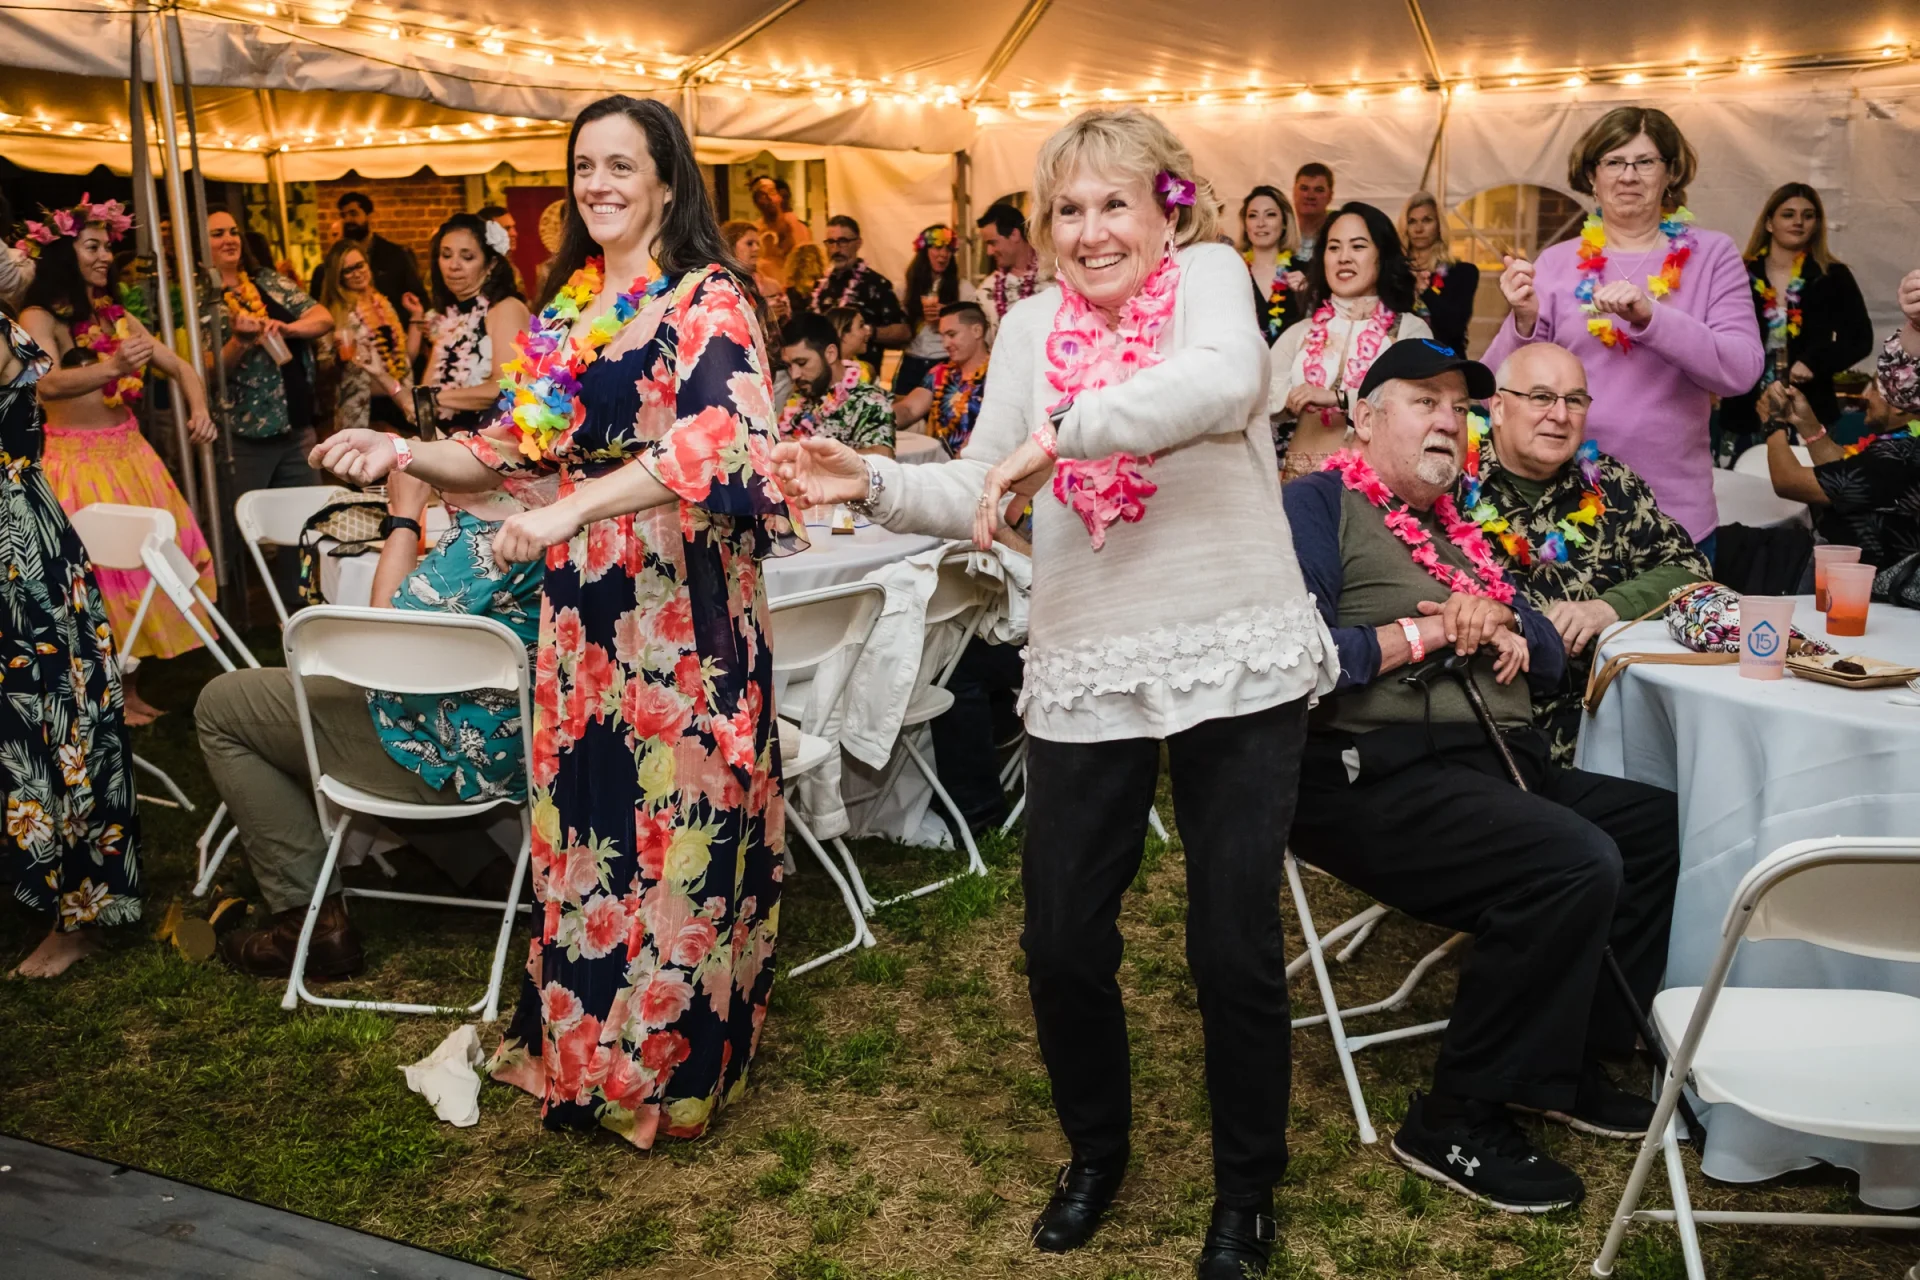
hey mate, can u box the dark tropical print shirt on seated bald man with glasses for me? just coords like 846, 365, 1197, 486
1463, 438, 1713, 766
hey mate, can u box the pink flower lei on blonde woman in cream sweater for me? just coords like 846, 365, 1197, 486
1046, 253, 1181, 551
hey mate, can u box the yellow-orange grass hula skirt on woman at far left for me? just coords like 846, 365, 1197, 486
40, 416, 215, 658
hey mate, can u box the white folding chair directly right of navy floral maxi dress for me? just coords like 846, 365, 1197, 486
768, 581, 887, 977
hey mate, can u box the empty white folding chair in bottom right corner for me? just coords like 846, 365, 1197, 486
1594, 837, 1920, 1280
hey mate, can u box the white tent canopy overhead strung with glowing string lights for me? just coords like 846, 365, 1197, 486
0, 0, 1920, 330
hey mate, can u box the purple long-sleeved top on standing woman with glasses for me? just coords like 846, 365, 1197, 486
1480, 226, 1766, 541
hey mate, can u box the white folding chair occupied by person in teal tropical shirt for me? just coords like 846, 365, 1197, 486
280, 604, 534, 1023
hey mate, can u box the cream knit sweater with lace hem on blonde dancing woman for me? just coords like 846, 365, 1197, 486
874, 244, 1338, 743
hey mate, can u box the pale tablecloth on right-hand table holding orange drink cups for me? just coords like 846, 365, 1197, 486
1578, 594, 1920, 1209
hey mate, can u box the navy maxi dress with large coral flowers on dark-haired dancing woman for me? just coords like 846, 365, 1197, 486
468, 269, 804, 1148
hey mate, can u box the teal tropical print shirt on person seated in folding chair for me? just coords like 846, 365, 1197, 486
367, 510, 547, 800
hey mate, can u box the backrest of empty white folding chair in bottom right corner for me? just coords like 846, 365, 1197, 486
1751, 837, 1920, 963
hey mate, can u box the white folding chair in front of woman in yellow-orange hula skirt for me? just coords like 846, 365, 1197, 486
71, 503, 259, 809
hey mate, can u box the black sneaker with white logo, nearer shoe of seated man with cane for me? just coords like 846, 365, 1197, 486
1392, 1094, 1586, 1213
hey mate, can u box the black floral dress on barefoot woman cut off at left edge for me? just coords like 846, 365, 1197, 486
0, 315, 140, 933
